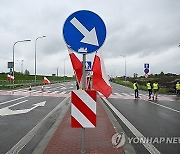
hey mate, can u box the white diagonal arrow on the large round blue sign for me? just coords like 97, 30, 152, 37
70, 17, 99, 46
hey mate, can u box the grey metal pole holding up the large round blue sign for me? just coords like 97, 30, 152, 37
81, 54, 86, 154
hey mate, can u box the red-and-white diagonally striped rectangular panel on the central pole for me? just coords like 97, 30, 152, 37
71, 90, 96, 128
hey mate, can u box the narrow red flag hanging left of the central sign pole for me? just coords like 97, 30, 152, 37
68, 49, 83, 84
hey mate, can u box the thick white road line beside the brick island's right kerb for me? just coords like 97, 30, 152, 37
102, 98, 160, 154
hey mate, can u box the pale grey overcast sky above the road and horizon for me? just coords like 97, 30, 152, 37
0, 0, 180, 76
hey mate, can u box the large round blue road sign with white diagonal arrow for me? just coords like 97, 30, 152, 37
63, 10, 106, 54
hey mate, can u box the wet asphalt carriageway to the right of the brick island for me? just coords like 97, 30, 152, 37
108, 83, 180, 154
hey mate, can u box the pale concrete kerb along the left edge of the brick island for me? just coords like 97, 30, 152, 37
32, 96, 70, 154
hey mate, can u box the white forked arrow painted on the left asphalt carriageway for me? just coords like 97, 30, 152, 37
0, 100, 46, 116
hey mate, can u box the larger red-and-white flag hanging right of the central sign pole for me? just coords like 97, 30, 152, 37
92, 51, 112, 98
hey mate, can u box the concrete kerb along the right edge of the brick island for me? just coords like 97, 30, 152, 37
100, 98, 136, 154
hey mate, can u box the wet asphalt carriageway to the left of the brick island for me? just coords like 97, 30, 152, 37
0, 82, 75, 154
